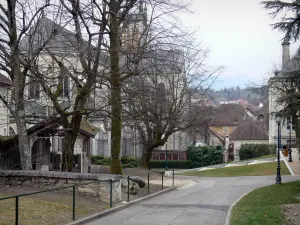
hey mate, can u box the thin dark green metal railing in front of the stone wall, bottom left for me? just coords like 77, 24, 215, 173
0, 179, 113, 225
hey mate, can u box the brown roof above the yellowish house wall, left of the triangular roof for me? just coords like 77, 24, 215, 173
210, 104, 247, 126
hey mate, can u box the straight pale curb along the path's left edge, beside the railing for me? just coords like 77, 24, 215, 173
67, 187, 176, 225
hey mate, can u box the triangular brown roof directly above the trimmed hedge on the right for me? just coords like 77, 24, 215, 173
230, 118, 269, 140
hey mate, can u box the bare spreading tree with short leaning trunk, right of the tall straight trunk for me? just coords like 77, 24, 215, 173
124, 43, 221, 167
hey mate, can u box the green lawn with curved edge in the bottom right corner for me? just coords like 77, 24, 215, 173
230, 181, 300, 225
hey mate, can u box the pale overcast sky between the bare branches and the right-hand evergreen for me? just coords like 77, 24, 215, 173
181, 0, 299, 88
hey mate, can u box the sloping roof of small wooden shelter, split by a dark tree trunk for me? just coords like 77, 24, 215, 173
27, 118, 100, 137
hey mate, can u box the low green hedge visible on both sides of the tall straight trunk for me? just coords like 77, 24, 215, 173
91, 156, 140, 168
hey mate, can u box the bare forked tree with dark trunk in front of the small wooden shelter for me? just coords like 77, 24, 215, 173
25, 0, 108, 171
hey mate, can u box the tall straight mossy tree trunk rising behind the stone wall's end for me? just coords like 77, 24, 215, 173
109, 0, 122, 174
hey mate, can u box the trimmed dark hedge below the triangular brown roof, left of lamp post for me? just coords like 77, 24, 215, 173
239, 144, 276, 160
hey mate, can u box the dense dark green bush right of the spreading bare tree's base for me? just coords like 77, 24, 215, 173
187, 145, 223, 168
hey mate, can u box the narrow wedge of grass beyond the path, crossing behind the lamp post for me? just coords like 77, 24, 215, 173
179, 162, 290, 177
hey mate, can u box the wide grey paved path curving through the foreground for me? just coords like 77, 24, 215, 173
89, 176, 300, 225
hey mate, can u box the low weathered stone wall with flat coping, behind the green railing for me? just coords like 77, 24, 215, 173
0, 170, 123, 203
